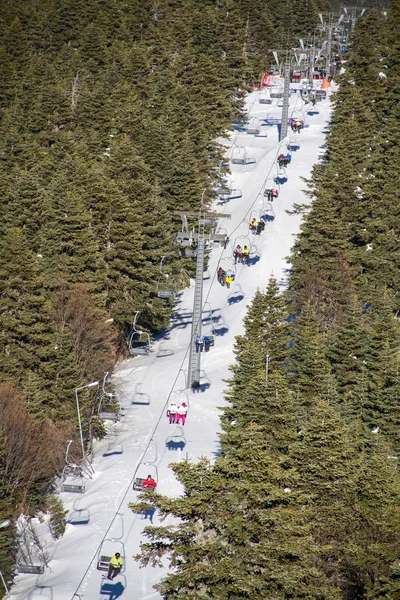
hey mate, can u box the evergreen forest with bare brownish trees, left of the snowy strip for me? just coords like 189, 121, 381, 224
0, 0, 326, 577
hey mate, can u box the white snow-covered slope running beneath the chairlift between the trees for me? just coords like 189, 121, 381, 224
10, 86, 331, 600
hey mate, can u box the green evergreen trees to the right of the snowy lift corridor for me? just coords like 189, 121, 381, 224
131, 1, 400, 600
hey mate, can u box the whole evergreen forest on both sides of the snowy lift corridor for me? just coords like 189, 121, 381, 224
0, 0, 400, 600
